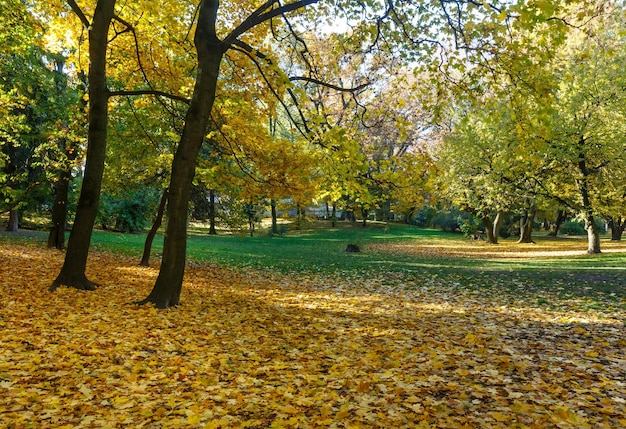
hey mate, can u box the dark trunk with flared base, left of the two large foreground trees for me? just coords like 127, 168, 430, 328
50, 0, 115, 291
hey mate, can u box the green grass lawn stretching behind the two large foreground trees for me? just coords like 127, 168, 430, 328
0, 222, 626, 307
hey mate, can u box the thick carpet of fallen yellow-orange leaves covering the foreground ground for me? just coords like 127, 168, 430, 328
0, 243, 626, 428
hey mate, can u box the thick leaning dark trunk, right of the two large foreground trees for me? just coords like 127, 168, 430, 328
140, 0, 224, 308
